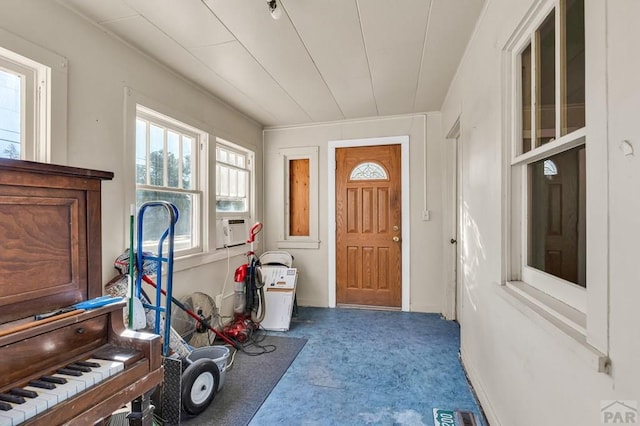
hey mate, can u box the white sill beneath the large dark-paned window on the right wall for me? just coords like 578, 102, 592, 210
499, 281, 610, 374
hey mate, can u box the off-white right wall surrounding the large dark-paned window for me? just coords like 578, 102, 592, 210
442, 0, 640, 426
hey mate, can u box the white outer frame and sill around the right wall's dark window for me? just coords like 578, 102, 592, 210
500, 0, 611, 366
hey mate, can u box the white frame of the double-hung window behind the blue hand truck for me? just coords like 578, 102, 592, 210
133, 104, 209, 258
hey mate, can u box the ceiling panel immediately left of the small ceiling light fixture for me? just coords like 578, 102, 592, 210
206, 0, 344, 121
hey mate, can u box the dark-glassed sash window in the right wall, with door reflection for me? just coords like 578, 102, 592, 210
507, 0, 588, 313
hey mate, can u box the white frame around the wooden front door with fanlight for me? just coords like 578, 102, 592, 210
327, 136, 411, 312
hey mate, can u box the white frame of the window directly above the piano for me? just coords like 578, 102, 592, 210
0, 29, 68, 164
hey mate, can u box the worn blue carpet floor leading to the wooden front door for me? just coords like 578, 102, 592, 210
250, 307, 486, 426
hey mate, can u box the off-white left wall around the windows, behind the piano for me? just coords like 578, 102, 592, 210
0, 0, 262, 306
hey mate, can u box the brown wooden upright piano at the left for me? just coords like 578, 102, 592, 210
0, 159, 163, 426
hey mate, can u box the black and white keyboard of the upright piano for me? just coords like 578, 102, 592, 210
0, 358, 124, 426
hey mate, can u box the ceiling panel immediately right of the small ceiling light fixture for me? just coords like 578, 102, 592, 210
283, 0, 377, 118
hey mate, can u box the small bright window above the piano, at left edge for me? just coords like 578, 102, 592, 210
0, 48, 51, 162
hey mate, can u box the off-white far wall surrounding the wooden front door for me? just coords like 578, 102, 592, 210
264, 113, 444, 312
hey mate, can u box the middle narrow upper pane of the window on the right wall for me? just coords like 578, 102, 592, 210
536, 12, 556, 147
